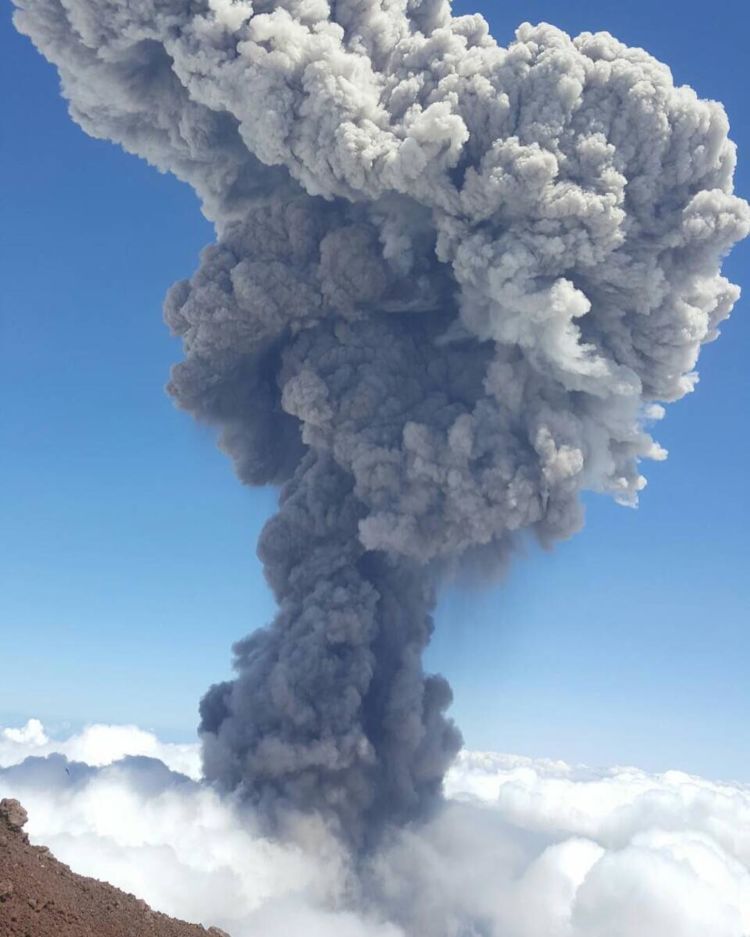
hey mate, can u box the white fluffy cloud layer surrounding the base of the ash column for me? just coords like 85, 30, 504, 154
0, 721, 750, 937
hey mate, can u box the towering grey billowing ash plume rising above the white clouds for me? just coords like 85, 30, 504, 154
16, 0, 750, 841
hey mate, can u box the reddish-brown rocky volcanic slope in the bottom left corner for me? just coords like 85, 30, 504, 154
0, 800, 228, 937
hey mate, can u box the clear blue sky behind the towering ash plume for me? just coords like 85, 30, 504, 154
0, 0, 750, 781
